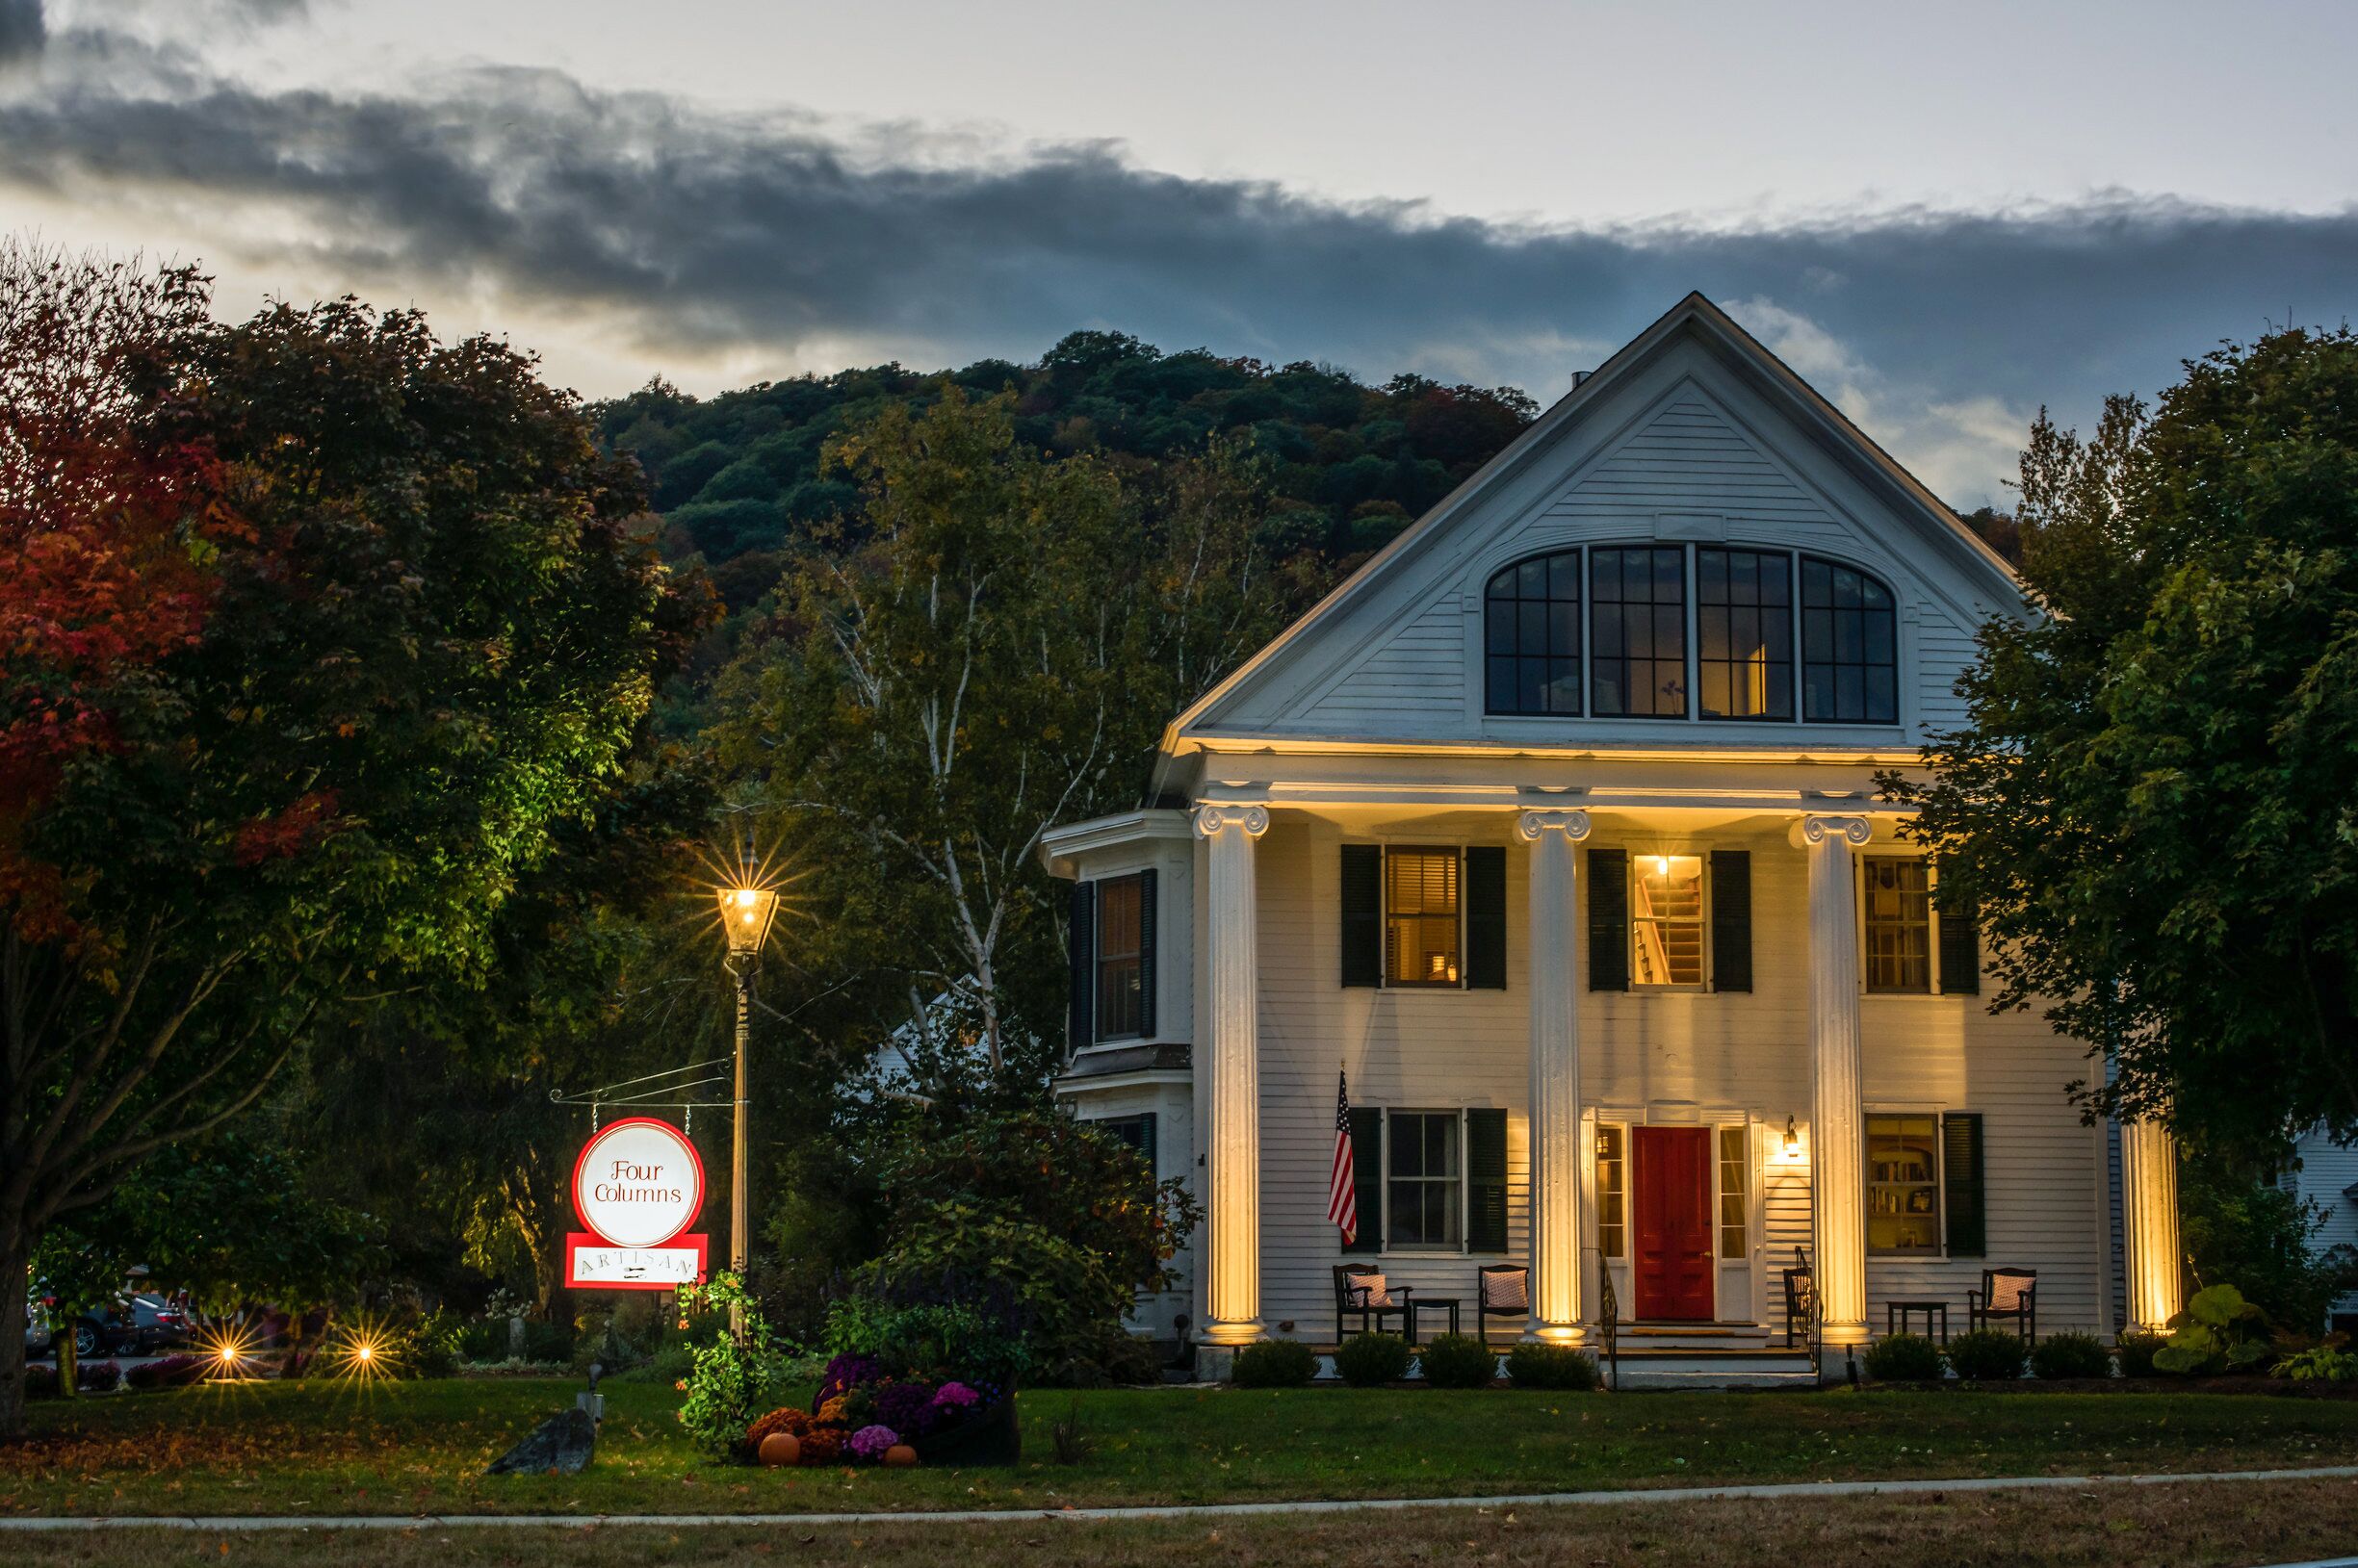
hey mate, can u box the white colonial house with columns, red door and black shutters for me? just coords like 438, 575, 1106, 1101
1045, 295, 2179, 1360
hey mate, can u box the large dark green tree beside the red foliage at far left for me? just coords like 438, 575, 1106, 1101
0, 281, 700, 1433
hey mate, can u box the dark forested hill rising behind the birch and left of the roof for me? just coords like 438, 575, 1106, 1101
594, 332, 1568, 604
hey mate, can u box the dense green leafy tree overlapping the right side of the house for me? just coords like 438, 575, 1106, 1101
1881, 330, 2358, 1146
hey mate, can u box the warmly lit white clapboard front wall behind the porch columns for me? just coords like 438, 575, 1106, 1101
1257, 811, 2111, 1339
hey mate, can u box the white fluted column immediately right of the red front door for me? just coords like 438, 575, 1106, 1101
1801, 816, 1870, 1344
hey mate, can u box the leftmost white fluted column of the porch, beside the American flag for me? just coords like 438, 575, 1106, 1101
1196, 807, 1269, 1344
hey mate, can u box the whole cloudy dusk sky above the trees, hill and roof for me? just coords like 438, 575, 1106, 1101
0, 0, 2358, 507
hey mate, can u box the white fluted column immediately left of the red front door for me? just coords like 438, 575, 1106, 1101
1516, 811, 1590, 1344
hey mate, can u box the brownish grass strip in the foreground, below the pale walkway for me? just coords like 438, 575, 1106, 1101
7, 1480, 2358, 1568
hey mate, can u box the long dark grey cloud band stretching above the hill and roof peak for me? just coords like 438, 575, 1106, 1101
0, 45, 2358, 486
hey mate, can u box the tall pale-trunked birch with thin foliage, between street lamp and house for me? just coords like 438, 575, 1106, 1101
716, 387, 1278, 1068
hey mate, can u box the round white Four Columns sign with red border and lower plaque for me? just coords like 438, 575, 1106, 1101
566, 1116, 705, 1290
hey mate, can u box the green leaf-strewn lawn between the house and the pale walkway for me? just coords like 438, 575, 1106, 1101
0, 1379, 2358, 1514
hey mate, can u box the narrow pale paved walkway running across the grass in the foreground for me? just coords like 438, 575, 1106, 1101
0, 1464, 2358, 1528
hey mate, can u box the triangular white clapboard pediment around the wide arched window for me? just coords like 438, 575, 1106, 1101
1165, 295, 2023, 752
